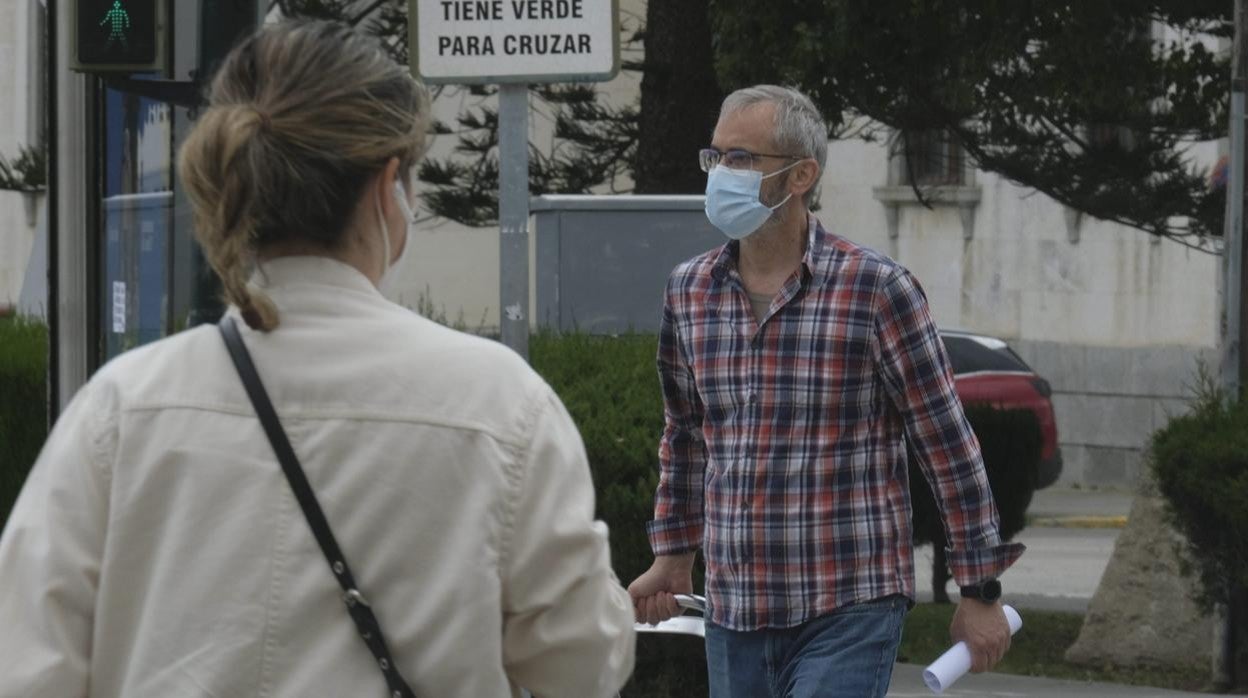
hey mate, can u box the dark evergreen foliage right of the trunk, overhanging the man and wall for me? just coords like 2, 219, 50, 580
710, 0, 1232, 246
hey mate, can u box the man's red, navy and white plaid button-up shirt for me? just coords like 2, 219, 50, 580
648, 216, 1023, 631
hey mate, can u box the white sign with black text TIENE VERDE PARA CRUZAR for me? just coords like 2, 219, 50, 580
408, 0, 619, 84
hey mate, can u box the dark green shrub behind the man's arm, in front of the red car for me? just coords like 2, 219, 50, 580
910, 405, 1043, 601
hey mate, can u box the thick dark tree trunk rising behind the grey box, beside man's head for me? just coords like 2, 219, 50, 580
633, 0, 724, 194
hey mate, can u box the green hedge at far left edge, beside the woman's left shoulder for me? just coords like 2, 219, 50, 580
0, 317, 47, 527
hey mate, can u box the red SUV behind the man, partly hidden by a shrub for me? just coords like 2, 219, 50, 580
941, 330, 1062, 489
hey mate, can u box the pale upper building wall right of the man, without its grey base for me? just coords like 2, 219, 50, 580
819, 132, 1219, 347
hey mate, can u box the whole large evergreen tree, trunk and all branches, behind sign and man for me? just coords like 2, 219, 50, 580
278, 0, 1232, 247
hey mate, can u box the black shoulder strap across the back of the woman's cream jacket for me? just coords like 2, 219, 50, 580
217, 316, 416, 698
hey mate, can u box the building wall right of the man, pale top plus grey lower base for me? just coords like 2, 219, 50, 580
820, 133, 1221, 487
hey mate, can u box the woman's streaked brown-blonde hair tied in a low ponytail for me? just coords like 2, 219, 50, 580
178, 20, 429, 331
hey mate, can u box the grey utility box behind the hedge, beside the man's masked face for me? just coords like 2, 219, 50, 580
529, 195, 728, 335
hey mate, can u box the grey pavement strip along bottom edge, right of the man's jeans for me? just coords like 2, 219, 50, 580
889, 664, 1211, 698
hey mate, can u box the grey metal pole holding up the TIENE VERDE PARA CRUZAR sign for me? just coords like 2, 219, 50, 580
498, 82, 529, 361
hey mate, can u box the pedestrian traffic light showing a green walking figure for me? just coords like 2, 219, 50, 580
69, 0, 170, 72
